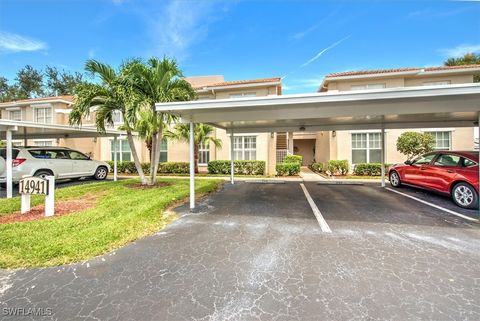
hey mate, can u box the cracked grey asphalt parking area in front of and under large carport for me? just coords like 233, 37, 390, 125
0, 182, 480, 321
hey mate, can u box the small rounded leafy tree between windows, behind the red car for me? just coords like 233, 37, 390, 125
397, 132, 435, 159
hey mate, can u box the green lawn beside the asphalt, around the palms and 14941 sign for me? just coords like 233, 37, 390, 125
0, 179, 221, 268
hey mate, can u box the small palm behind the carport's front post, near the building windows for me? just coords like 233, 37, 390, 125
165, 123, 222, 173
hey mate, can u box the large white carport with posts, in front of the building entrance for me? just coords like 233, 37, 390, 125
156, 84, 480, 215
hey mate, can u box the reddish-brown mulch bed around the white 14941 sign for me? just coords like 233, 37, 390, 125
0, 195, 98, 224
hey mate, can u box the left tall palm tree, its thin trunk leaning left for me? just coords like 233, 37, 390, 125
69, 60, 146, 184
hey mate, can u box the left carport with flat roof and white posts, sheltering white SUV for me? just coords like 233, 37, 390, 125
0, 119, 125, 198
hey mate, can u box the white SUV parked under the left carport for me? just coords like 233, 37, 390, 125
0, 147, 110, 185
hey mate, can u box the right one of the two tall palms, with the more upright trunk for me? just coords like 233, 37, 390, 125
127, 57, 196, 184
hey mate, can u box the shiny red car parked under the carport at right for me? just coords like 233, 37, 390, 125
388, 151, 478, 208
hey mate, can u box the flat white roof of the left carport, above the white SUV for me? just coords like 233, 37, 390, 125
0, 119, 126, 139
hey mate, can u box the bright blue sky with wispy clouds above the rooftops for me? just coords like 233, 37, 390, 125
0, 0, 480, 93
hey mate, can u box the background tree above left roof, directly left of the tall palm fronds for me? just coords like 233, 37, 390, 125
45, 66, 83, 96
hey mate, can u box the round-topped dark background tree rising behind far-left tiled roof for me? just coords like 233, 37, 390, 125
15, 65, 45, 99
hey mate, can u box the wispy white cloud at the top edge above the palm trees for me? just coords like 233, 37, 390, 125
148, 0, 232, 60
